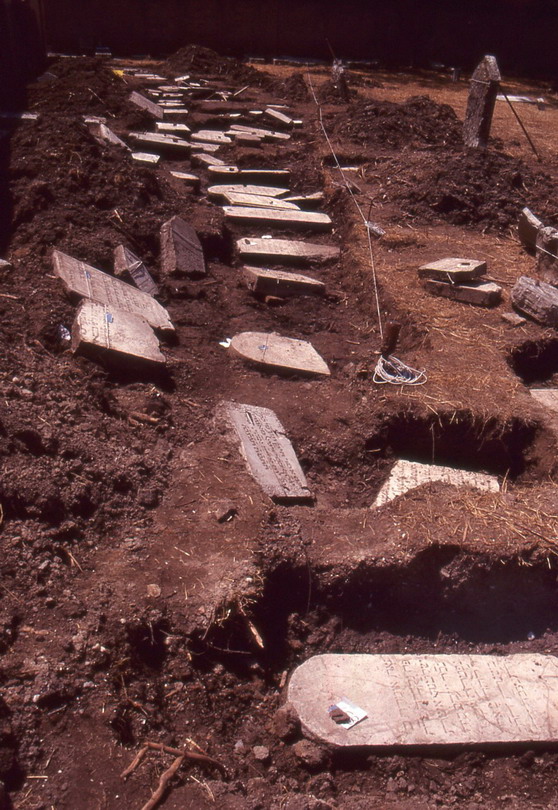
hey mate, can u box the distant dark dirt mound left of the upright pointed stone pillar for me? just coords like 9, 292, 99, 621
335, 96, 461, 147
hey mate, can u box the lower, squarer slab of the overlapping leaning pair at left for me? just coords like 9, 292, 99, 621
72, 299, 165, 363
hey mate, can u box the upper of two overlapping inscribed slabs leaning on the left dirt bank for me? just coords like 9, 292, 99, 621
52, 250, 174, 331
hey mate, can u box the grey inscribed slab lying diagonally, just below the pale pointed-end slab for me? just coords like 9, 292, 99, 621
220, 402, 313, 503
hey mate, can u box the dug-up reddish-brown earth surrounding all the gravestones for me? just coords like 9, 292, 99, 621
0, 46, 558, 810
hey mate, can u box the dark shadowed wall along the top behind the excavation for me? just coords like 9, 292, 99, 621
44, 0, 558, 77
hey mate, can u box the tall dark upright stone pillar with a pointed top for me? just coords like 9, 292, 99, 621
463, 56, 501, 148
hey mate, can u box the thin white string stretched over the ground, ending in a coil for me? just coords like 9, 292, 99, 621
306, 73, 428, 385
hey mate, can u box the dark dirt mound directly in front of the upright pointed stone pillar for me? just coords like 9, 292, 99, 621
395, 150, 556, 230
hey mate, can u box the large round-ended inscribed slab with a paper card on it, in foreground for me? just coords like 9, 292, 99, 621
288, 653, 558, 748
